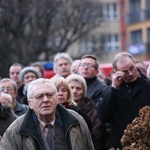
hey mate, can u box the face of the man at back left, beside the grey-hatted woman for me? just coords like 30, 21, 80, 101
9, 66, 22, 83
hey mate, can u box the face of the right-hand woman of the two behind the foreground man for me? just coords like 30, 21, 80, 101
68, 81, 84, 102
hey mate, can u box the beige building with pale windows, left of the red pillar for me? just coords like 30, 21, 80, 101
68, 0, 122, 63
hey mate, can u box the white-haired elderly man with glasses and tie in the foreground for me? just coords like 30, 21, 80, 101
0, 78, 94, 150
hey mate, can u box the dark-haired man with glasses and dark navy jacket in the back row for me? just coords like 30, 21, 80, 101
78, 54, 105, 104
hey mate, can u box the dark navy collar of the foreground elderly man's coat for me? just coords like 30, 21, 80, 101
19, 104, 79, 149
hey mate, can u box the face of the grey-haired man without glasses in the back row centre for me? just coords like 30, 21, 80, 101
56, 58, 71, 78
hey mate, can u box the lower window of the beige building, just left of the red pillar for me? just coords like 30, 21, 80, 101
104, 34, 120, 52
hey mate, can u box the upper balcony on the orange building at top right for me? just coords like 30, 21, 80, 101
127, 10, 150, 25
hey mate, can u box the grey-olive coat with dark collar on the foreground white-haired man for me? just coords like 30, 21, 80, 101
0, 104, 94, 150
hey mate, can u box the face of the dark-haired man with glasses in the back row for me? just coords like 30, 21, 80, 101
78, 58, 98, 78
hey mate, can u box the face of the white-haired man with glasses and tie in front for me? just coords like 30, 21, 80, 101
28, 83, 58, 120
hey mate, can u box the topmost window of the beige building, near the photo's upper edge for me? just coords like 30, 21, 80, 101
102, 3, 118, 21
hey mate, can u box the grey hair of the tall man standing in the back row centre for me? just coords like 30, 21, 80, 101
53, 53, 73, 73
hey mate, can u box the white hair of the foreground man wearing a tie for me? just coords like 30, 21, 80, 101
27, 78, 57, 99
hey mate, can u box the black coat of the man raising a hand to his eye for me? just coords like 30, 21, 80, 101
97, 73, 150, 148
